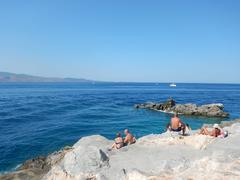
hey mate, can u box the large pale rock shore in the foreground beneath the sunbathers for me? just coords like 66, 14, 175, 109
0, 119, 240, 180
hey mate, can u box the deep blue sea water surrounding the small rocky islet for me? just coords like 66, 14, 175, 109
0, 83, 240, 172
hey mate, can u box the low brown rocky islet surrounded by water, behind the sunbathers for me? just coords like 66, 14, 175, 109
134, 99, 229, 118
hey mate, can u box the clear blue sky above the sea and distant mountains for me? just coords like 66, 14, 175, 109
0, 0, 240, 83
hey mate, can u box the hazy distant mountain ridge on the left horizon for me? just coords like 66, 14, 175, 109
0, 72, 95, 83
